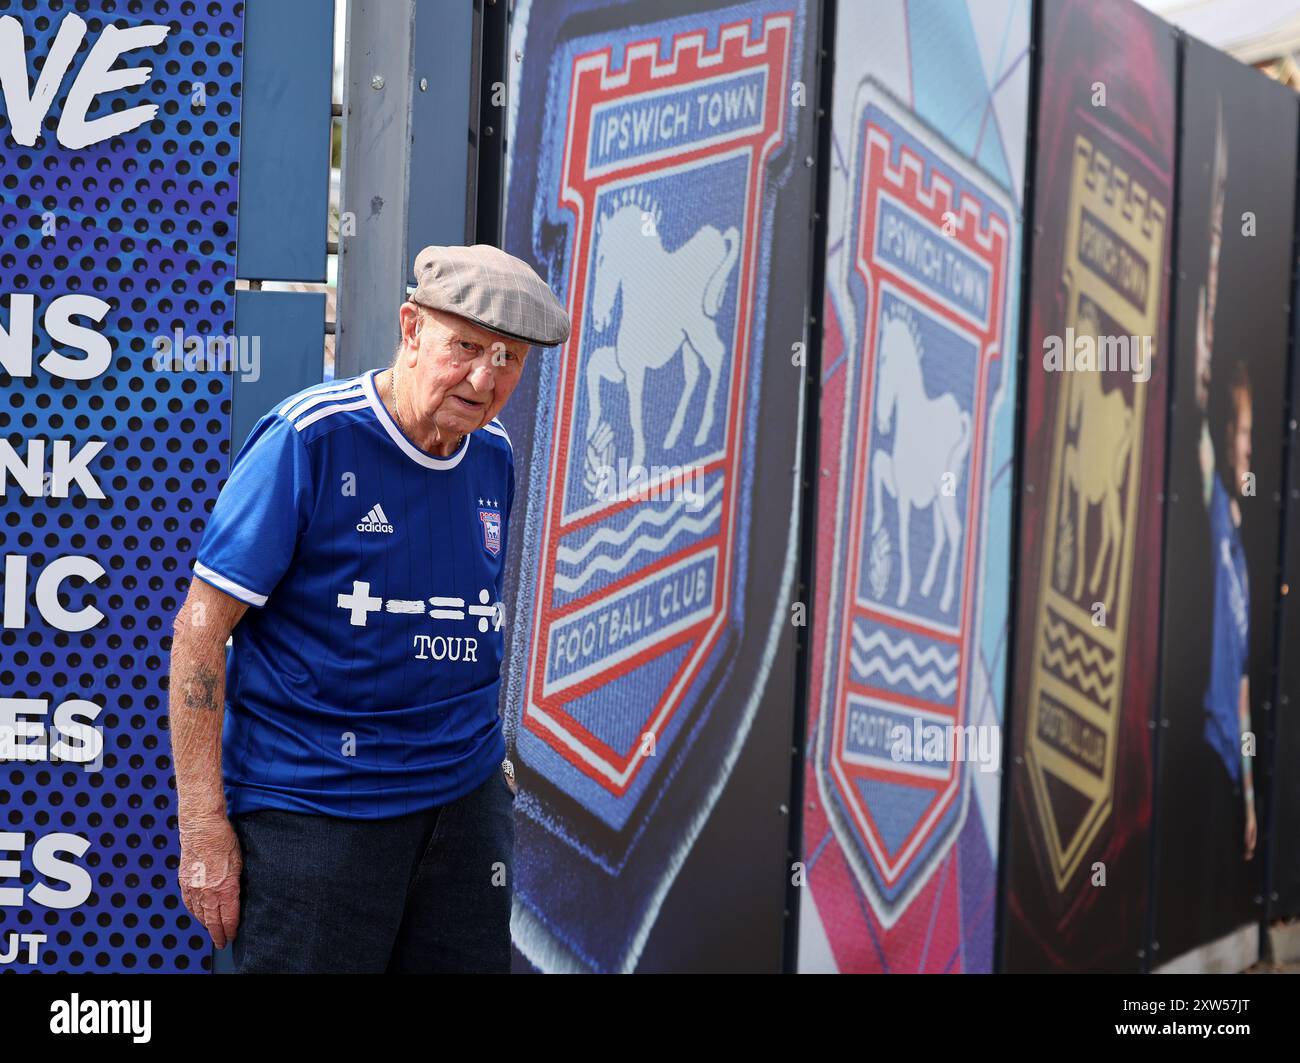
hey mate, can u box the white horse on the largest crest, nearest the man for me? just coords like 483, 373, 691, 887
586, 185, 740, 467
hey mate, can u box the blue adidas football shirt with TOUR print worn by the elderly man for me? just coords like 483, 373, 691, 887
194, 370, 515, 819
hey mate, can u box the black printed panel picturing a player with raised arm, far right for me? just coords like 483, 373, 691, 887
1152, 39, 1300, 971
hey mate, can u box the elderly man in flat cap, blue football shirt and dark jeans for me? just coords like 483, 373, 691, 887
170, 246, 569, 972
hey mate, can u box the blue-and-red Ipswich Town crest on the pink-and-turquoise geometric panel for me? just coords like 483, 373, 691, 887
815, 83, 1014, 928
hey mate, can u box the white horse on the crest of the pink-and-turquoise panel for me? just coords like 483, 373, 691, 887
871, 306, 971, 612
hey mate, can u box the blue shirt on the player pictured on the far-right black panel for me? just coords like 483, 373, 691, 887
1204, 476, 1251, 782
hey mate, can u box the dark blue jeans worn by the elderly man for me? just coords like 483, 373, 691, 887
231, 767, 515, 973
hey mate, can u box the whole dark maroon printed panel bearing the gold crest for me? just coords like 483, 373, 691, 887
1004, 0, 1175, 971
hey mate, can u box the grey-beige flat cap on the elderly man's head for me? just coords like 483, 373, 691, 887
410, 243, 569, 347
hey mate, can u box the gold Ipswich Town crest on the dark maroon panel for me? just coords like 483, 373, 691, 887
1026, 135, 1165, 893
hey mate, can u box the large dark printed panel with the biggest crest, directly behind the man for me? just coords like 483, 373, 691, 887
506, 1, 815, 971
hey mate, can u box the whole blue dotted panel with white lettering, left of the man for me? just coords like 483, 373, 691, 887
0, 0, 243, 972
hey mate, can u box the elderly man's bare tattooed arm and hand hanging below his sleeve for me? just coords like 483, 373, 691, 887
168, 578, 248, 949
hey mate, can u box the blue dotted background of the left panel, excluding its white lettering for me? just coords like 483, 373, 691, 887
0, 0, 243, 972
